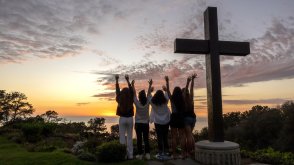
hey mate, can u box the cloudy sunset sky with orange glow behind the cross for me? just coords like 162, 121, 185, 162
0, 0, 294, 117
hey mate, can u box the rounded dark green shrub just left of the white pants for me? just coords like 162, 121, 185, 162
97, 141, 126, 162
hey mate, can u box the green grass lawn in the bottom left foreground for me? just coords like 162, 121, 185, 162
0, 136, 146, 165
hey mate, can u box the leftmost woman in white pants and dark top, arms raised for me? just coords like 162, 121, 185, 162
115, 75, 134, 159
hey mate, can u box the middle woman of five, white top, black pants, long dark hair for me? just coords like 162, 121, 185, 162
150, 78, 170, 159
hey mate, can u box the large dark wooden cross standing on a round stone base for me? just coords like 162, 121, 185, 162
174, 7, 250, 142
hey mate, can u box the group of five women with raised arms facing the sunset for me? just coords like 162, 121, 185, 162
115, 74, 197, 159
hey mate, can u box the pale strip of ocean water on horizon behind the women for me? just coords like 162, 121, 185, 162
63, 116, 208, 132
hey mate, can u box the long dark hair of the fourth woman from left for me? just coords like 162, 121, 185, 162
171, 86, 186, 112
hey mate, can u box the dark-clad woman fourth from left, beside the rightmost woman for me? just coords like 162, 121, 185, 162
164, 76, 185, 159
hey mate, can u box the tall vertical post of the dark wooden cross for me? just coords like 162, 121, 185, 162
204, 8, 224, 142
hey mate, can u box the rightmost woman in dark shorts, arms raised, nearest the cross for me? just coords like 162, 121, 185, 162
183, 73, 197, 157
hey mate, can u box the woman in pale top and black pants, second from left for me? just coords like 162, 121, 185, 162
132, 79, 153, 160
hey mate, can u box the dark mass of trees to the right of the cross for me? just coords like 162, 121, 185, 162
224, 101, 294, 152
